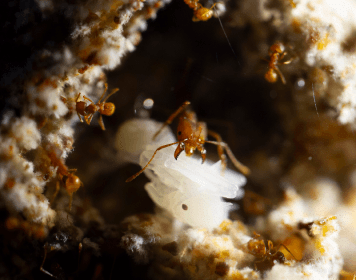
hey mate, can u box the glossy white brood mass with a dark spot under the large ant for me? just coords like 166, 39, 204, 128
118, 120, 246, 229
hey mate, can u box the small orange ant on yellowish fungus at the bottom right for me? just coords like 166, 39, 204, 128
247, 233, 297, 268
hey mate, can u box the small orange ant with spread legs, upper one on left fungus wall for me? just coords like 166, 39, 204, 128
75, 83, 119, 130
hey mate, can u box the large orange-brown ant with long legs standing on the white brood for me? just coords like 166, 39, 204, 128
126, 101, 250, 183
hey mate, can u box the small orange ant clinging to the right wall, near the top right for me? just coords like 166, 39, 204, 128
265, 42, 293, 84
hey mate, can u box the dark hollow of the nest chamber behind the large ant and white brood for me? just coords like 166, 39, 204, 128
67, 1, 284, 223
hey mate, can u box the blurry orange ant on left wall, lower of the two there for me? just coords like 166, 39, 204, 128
47, 149, 83, 211
